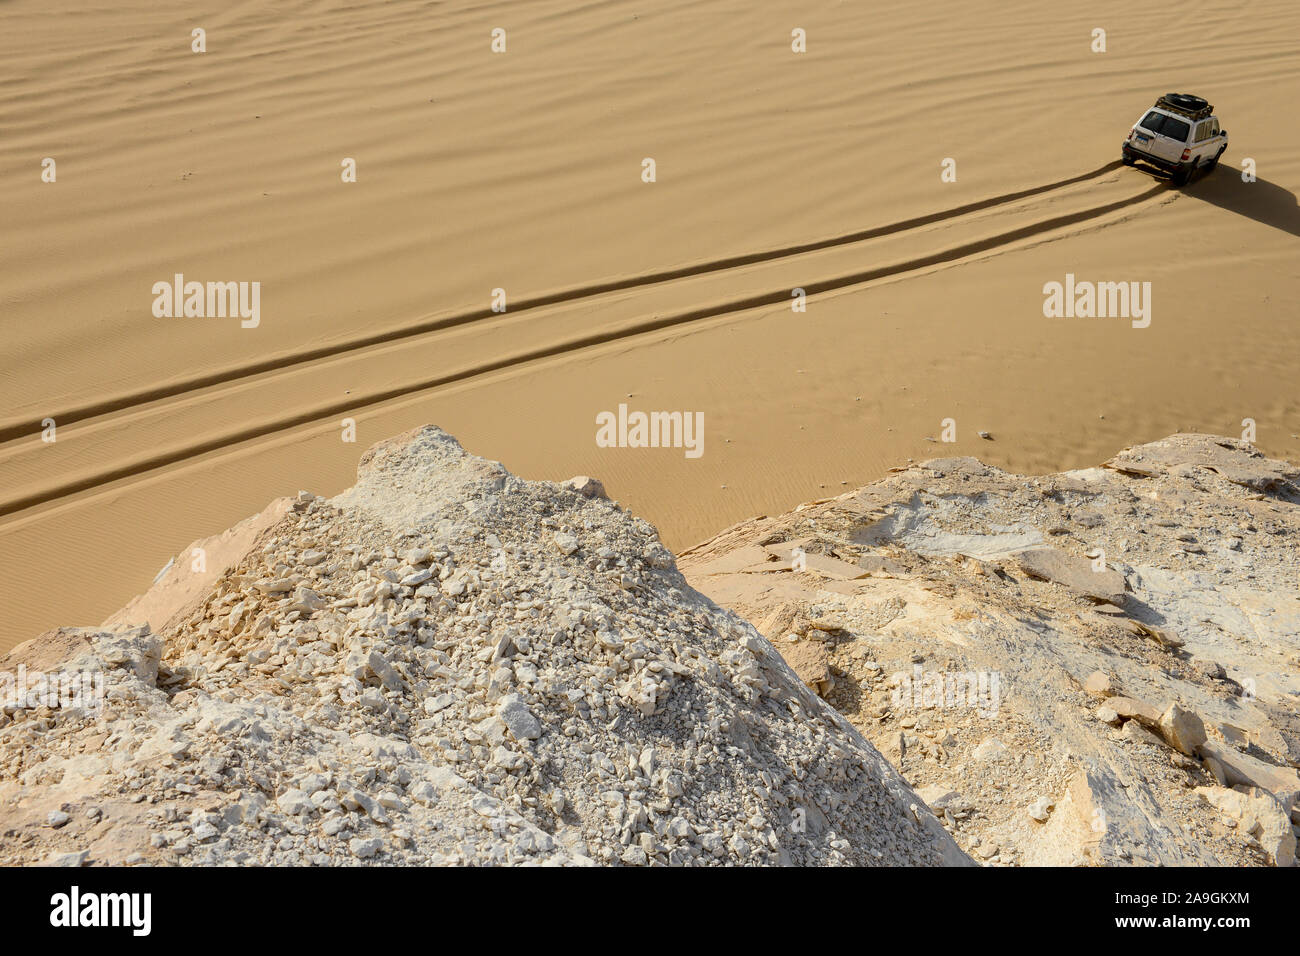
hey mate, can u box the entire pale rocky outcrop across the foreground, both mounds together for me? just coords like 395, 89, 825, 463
0, 428, 1300, 866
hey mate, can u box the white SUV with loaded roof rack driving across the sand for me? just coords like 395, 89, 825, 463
1123, 92, 1227, 186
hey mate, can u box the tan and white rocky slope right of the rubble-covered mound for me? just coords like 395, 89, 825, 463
679, 434, 1300, 865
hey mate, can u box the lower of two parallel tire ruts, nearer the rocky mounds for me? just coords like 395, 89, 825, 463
0, 179, 1169, 516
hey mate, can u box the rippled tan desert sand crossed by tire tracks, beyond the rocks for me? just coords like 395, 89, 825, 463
0, 0, 1300, 648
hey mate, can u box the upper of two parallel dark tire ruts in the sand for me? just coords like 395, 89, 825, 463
0, 160, 1122, 447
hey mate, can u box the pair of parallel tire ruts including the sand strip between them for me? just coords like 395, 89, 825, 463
0, 163, 1177, 516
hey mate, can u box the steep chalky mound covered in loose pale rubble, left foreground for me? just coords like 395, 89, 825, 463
0, 427, 969, 865
